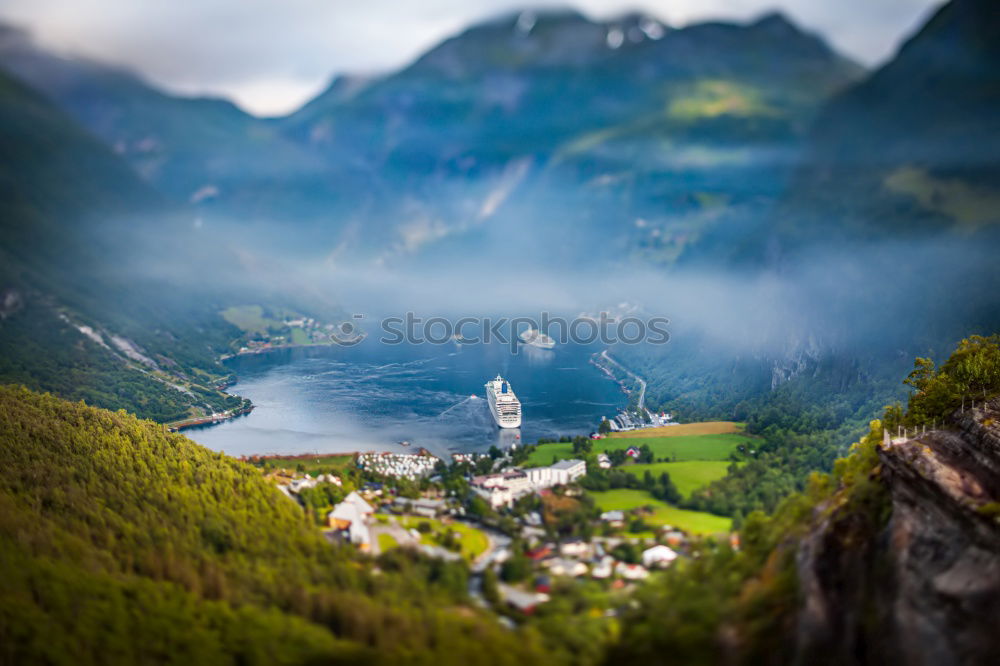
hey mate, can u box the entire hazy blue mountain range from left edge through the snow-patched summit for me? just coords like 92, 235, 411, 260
0, 11, 861, 263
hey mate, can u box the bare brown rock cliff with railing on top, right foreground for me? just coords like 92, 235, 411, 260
795, 400, 1000, 666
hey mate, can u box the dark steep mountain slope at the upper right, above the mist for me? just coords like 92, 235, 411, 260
778, 0, 1000, 252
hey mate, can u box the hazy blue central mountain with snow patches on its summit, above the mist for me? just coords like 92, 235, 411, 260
281, 11, 861, 262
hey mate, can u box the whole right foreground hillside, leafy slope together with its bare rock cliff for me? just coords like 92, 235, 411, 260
608, 335, 1000, 665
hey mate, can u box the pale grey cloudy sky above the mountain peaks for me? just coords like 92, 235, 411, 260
0, 0, 940, 115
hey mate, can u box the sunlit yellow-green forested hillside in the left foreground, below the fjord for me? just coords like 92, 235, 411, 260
0, 386, 552, 664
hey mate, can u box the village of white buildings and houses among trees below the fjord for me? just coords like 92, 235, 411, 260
251, 422, 752, 618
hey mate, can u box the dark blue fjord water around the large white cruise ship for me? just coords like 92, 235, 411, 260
185, 340, 626, 456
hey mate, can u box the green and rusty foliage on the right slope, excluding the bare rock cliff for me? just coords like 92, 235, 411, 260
607, 336, 997, 664
